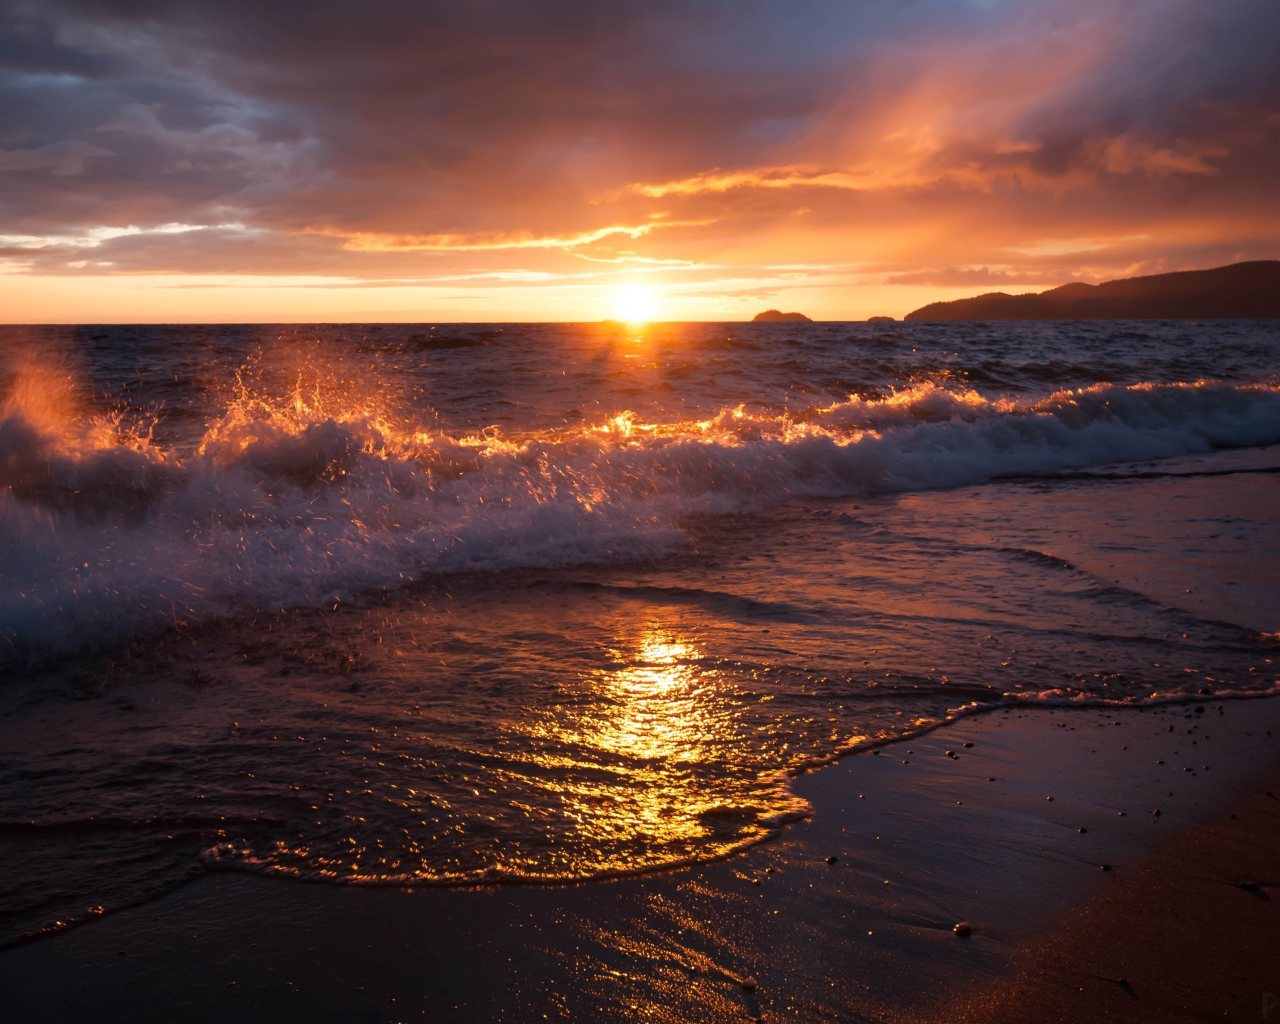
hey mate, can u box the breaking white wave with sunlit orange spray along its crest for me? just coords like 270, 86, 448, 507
0, 375, 1280, 655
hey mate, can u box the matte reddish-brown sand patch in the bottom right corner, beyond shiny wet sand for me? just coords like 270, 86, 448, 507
945, 774, 1280, 1024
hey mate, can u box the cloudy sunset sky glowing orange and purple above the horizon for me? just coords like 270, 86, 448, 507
0, 0, 1280, 323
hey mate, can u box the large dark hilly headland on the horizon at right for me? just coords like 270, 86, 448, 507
901, 260, 1280, 320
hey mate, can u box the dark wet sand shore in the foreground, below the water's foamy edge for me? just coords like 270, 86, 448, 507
0, 699, 1280, 1021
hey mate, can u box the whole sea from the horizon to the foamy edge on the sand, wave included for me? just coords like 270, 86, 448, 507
0, 321, 1280, 945
